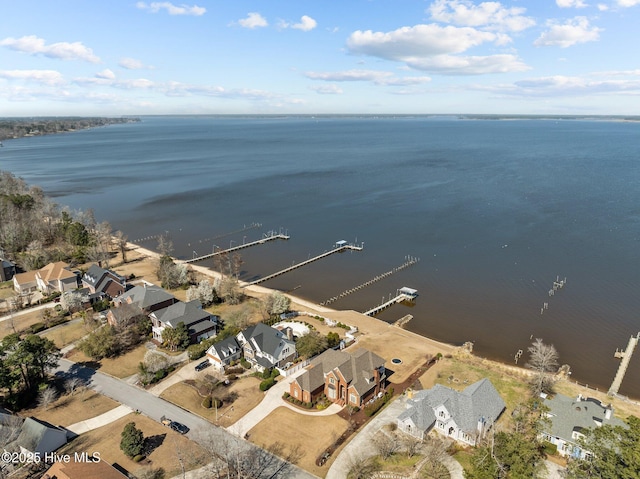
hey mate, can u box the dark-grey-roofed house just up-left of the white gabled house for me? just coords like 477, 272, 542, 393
149, 299, 220, 343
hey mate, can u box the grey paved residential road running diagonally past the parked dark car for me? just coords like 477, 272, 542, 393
54, 359, 315, 479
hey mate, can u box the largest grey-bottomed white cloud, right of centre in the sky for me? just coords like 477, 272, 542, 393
347, 24, 529, 75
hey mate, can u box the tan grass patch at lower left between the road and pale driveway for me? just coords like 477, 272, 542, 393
21, 389, 120, 427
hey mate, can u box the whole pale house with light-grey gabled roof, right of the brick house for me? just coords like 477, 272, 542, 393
398, 378, 506, 446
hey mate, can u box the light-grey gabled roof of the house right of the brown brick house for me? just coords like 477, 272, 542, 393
398, 378, 505, 433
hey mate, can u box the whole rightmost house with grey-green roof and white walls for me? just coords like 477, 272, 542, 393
542, 394, 626, 459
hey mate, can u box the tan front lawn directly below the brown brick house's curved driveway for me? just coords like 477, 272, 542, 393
249, 407, 349, 477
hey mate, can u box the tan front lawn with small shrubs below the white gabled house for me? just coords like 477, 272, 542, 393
160, 376, 264, 427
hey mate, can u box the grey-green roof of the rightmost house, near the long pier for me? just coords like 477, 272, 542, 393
544, 394, 625, 441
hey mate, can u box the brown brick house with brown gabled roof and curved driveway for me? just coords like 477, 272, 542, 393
289, 349, 387, 407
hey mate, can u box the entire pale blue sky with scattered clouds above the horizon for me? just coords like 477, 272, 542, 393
0, 0, 640, 117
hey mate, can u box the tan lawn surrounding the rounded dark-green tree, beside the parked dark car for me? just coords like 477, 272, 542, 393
58, 414, 209, 477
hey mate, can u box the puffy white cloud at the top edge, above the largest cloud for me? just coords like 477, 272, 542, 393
428, 0, 536, 32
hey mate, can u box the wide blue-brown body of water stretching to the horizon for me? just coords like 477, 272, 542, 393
0, 117, 640, 397
